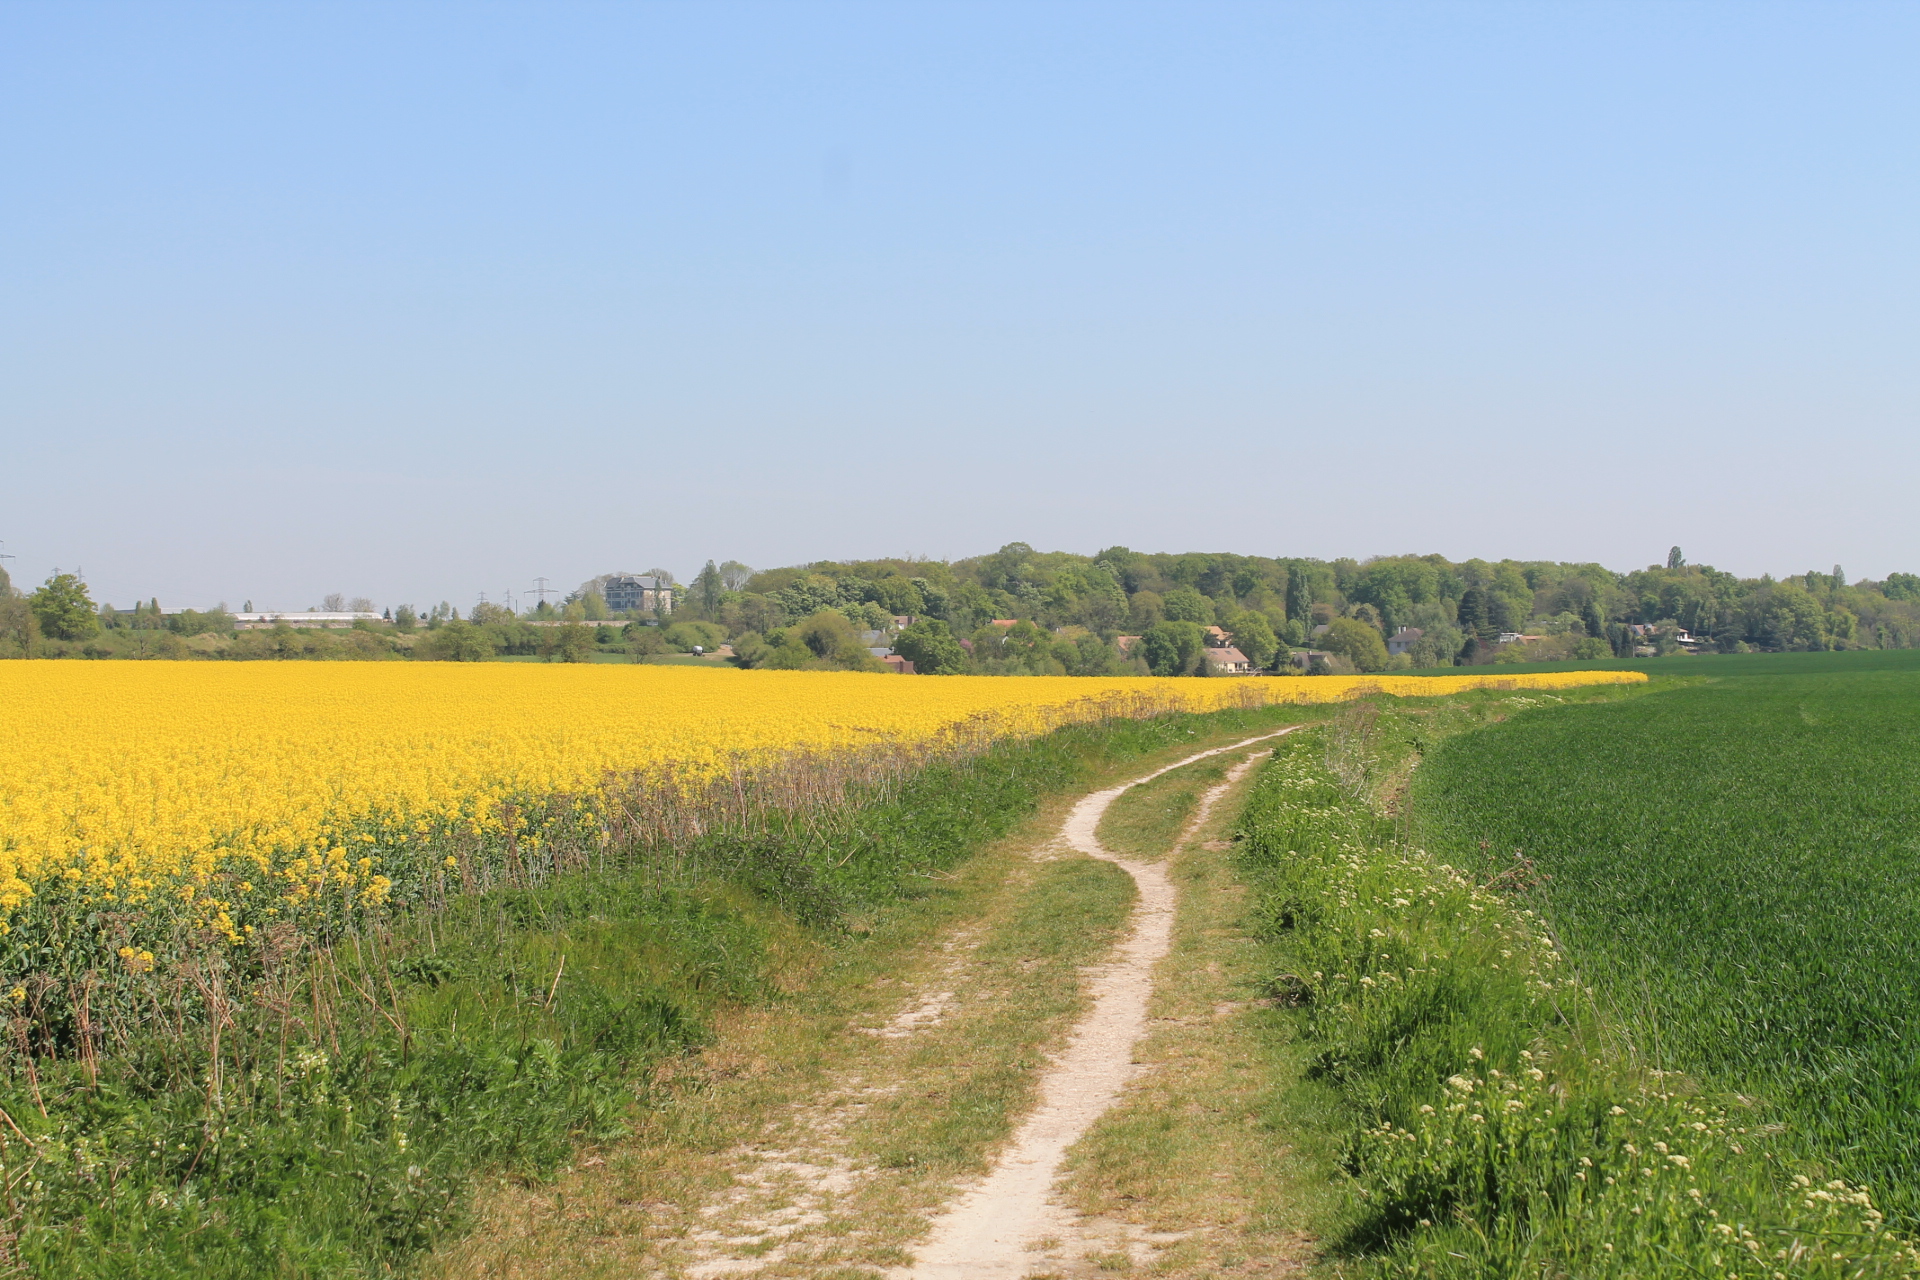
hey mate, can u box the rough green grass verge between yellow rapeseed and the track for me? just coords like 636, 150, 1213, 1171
0, 708, 1300, 1278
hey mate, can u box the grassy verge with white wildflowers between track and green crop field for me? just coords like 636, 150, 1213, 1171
1238, 691, 1920, 1278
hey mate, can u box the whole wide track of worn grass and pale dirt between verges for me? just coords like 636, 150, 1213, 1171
439, 729, 1296, 1280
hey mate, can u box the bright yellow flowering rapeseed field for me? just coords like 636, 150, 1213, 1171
0, 662, 1645, 936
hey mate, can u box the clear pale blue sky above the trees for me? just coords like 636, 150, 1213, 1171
0, 0, 1920, 608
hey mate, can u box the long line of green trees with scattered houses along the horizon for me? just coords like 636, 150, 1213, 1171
0, 543, 1920, 676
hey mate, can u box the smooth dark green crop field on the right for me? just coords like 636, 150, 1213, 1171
1415, 667, 1920, 1228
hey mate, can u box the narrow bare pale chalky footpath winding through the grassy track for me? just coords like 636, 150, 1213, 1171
893, 729, 1292, 1280
